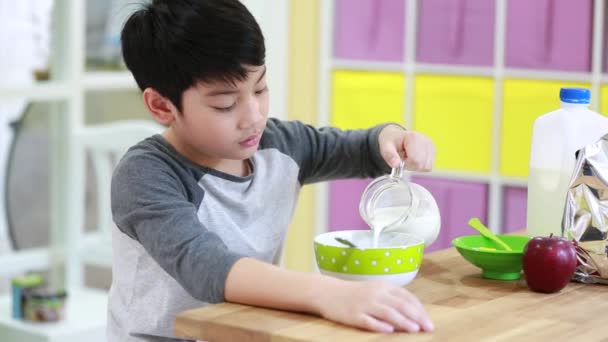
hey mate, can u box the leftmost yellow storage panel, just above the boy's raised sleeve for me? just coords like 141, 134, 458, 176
330, 71, 404, 129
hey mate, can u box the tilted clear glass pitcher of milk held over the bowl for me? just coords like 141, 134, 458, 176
359, 160, 441, 247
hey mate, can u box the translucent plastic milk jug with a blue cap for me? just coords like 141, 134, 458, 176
527, 88, 608, 236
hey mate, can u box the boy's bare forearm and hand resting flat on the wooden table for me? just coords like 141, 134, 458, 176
225, 258, 434, 332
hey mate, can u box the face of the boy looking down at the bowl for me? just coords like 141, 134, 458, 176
166, 66, 268, 172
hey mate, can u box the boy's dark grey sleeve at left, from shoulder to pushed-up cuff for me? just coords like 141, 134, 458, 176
112, 154, 244, 303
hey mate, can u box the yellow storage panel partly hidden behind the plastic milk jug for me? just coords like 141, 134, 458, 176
500, 80, 590, 177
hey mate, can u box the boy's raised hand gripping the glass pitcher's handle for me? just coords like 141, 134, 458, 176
378, 125, 436, 171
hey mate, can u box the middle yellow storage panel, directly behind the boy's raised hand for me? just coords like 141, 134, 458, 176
414, 75, 494, 173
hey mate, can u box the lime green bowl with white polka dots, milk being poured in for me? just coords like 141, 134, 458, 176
314, 230, 424, 286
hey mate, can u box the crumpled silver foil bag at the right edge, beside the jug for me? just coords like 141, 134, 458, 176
562, 134, 608, 284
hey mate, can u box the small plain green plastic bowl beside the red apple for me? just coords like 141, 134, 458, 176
452, 235, 530, 280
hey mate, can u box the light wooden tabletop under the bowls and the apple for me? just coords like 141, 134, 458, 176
175, 248, 608, 342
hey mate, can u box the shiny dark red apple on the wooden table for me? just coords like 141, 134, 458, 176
522, 234, 577, 293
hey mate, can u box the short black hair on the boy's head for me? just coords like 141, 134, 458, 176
121, 0, 265, 112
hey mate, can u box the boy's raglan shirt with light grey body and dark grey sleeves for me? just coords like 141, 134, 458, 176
108, 119, 389, 341
